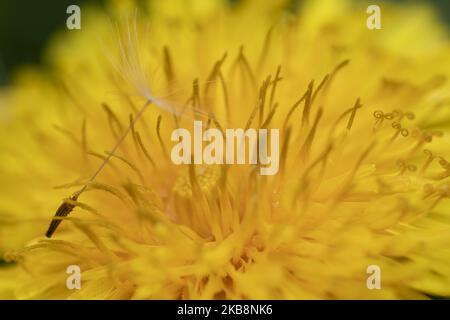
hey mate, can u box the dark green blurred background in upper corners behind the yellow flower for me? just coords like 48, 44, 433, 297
0, 0, 450, 85
